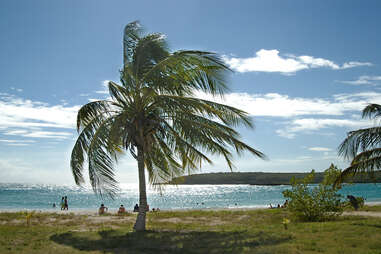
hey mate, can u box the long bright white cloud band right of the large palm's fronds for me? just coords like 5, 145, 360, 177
196, 92, 381, 117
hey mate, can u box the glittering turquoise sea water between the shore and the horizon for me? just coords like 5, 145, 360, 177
0, 183, 381, 210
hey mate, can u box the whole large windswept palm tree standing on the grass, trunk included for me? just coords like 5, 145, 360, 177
71, 22, 264, 231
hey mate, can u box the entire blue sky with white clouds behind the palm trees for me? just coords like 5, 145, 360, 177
0, 0, 381, 185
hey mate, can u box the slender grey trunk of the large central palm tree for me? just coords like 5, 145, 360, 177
134, 146, 147, 231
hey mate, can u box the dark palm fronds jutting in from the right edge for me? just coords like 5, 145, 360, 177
335, 104, 381, 184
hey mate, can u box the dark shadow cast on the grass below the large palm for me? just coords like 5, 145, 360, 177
50, 230, 292, 254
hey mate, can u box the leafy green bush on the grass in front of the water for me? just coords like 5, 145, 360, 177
283, 164, 343, 221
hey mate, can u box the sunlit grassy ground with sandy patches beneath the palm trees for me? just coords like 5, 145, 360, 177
0, 206, 381, 254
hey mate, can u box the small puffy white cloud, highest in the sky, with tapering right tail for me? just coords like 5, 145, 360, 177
223, 49, 372, 74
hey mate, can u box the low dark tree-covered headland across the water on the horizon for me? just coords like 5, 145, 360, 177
169, 172, 381, 185
